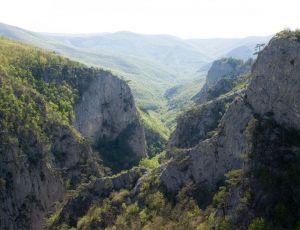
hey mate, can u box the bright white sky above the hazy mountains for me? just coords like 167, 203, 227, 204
0, 0, 300, 38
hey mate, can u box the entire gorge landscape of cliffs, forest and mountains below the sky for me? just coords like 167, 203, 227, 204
0, 25, 300, 230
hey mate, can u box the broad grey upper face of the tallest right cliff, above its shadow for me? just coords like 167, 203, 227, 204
246, 39, 300, 129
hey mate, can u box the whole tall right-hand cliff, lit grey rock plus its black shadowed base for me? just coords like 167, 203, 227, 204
161, 32, 300, 229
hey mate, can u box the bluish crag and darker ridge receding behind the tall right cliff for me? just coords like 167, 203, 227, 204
168, 58, 252, 153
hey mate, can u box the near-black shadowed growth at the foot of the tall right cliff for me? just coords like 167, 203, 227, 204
248, 117, 300, 229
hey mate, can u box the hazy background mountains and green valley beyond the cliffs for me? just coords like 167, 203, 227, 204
0, 23, 271, 123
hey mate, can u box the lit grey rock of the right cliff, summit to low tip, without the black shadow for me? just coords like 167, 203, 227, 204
161, 38, 300, 191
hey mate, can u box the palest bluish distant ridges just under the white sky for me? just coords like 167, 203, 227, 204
0, 23, 271, 78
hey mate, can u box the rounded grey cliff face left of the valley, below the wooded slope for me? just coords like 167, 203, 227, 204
74, 73, 146, 157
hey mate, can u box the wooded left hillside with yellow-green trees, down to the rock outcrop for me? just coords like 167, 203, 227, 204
0, 38, 109, 182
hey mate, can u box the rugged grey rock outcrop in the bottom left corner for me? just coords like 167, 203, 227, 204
0, 140, 65, 229
